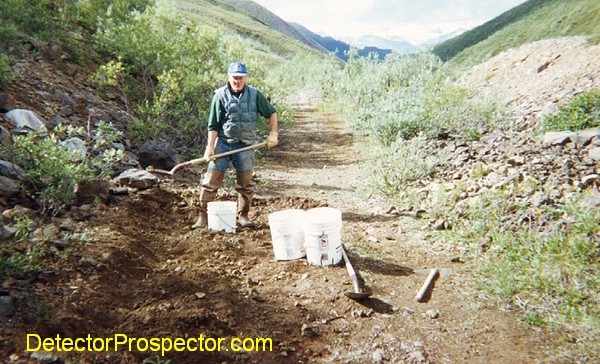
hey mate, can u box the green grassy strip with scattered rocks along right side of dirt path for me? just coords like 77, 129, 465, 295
396, 163, 600, 361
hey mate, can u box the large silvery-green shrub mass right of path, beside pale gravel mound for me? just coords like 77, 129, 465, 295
326, 53, 504, 147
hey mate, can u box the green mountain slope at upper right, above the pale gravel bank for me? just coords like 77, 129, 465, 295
432, 0, 600, 66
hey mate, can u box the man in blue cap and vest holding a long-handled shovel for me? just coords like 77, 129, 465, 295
192, 62, 278, 229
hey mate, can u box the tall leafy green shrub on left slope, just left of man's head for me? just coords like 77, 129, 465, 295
95, 4, 230, 154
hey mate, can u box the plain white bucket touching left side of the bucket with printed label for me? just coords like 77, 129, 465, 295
269, 209, 306, 260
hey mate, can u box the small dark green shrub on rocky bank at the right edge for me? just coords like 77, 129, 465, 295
541, 89, 600, 132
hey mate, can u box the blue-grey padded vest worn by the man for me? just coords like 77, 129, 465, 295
215, 85, 258, 144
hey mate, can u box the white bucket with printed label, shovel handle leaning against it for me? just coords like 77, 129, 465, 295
304, 207, 342, 265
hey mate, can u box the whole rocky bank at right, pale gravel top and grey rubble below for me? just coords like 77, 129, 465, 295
412, 37, 600, 232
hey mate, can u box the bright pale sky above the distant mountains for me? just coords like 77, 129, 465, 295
254, 0, 526, 45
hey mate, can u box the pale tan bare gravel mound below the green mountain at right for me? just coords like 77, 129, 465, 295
461, 37, 600, 130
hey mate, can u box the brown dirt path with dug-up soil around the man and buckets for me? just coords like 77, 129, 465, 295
2, 100, 559, 363
